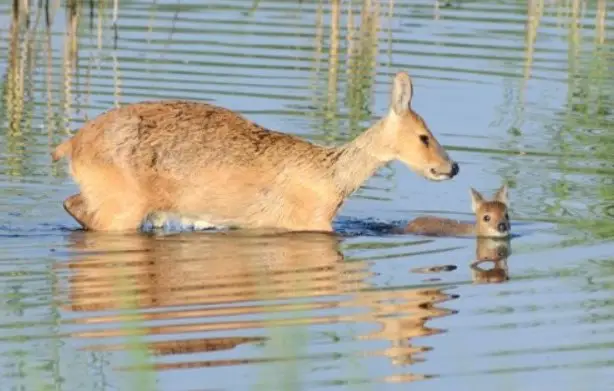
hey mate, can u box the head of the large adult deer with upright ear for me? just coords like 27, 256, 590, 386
386, 72, 459, 181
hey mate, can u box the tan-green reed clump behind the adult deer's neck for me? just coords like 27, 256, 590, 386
311, 0, 393, 143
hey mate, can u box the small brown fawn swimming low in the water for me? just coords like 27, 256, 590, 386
403, 185, 510, 237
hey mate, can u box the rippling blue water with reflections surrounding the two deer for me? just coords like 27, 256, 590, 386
0, 0, 614, 390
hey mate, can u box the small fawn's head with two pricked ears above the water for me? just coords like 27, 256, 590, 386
471, 185, 511, 238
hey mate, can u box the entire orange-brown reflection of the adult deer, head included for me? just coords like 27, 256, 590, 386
57, 231, 458, 381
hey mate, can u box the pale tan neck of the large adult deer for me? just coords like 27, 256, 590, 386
333, 119, 394, 198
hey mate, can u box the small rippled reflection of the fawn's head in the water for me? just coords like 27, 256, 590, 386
470, 238, 511, 284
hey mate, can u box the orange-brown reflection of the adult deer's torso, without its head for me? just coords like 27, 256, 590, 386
59, 232, 364, 364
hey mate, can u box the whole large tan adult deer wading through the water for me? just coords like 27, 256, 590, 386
52, 72, 458, 231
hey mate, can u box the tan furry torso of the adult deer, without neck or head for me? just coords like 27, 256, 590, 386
62, 102, 354, 230
